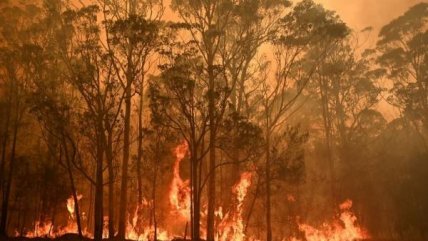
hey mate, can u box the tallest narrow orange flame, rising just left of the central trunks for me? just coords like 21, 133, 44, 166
169, 142, 190, 221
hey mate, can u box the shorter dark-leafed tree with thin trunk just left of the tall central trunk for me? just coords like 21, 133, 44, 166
150, 39, 209, 240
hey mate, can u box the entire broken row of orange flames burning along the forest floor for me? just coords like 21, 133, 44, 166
13, 143, 369, 241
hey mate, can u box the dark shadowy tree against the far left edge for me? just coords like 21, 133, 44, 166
0, 4, 44, 235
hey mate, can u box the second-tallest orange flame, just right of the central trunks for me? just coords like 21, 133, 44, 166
216, 172, 252, 241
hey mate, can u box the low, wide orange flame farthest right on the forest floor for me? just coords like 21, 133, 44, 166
291, 200, 369, 241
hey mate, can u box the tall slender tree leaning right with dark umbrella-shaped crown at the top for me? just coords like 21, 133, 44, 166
254, 0, 348, 241
